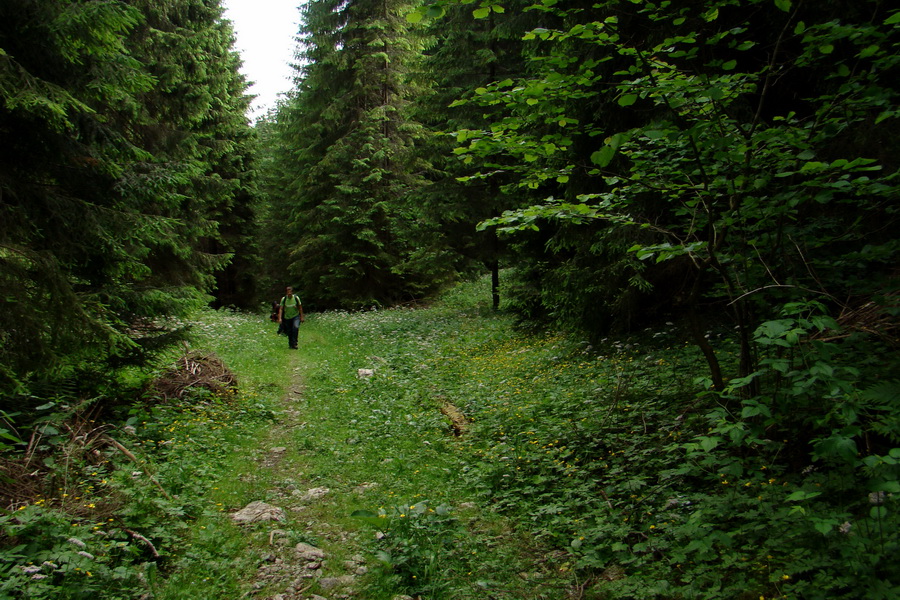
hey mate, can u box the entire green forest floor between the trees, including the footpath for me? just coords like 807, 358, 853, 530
0, 279, 898, 600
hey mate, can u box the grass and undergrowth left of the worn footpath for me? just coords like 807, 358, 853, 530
0, 311, 287, 600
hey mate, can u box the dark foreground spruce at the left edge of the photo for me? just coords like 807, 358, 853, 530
0, 0, 155, 394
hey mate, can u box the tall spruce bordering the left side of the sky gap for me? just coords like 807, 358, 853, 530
125, 0, 255, 306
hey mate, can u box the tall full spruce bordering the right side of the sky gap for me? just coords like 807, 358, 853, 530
273, 0, 448, 307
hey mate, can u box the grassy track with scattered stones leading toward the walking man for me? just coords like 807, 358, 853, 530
169, 280, 579, 600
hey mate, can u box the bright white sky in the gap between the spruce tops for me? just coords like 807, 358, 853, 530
222, 0, 303, 120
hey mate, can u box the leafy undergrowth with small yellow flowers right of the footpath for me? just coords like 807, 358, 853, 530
284, 276, 900, 599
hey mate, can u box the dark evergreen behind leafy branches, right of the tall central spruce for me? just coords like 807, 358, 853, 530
410, 2, 536, 307
